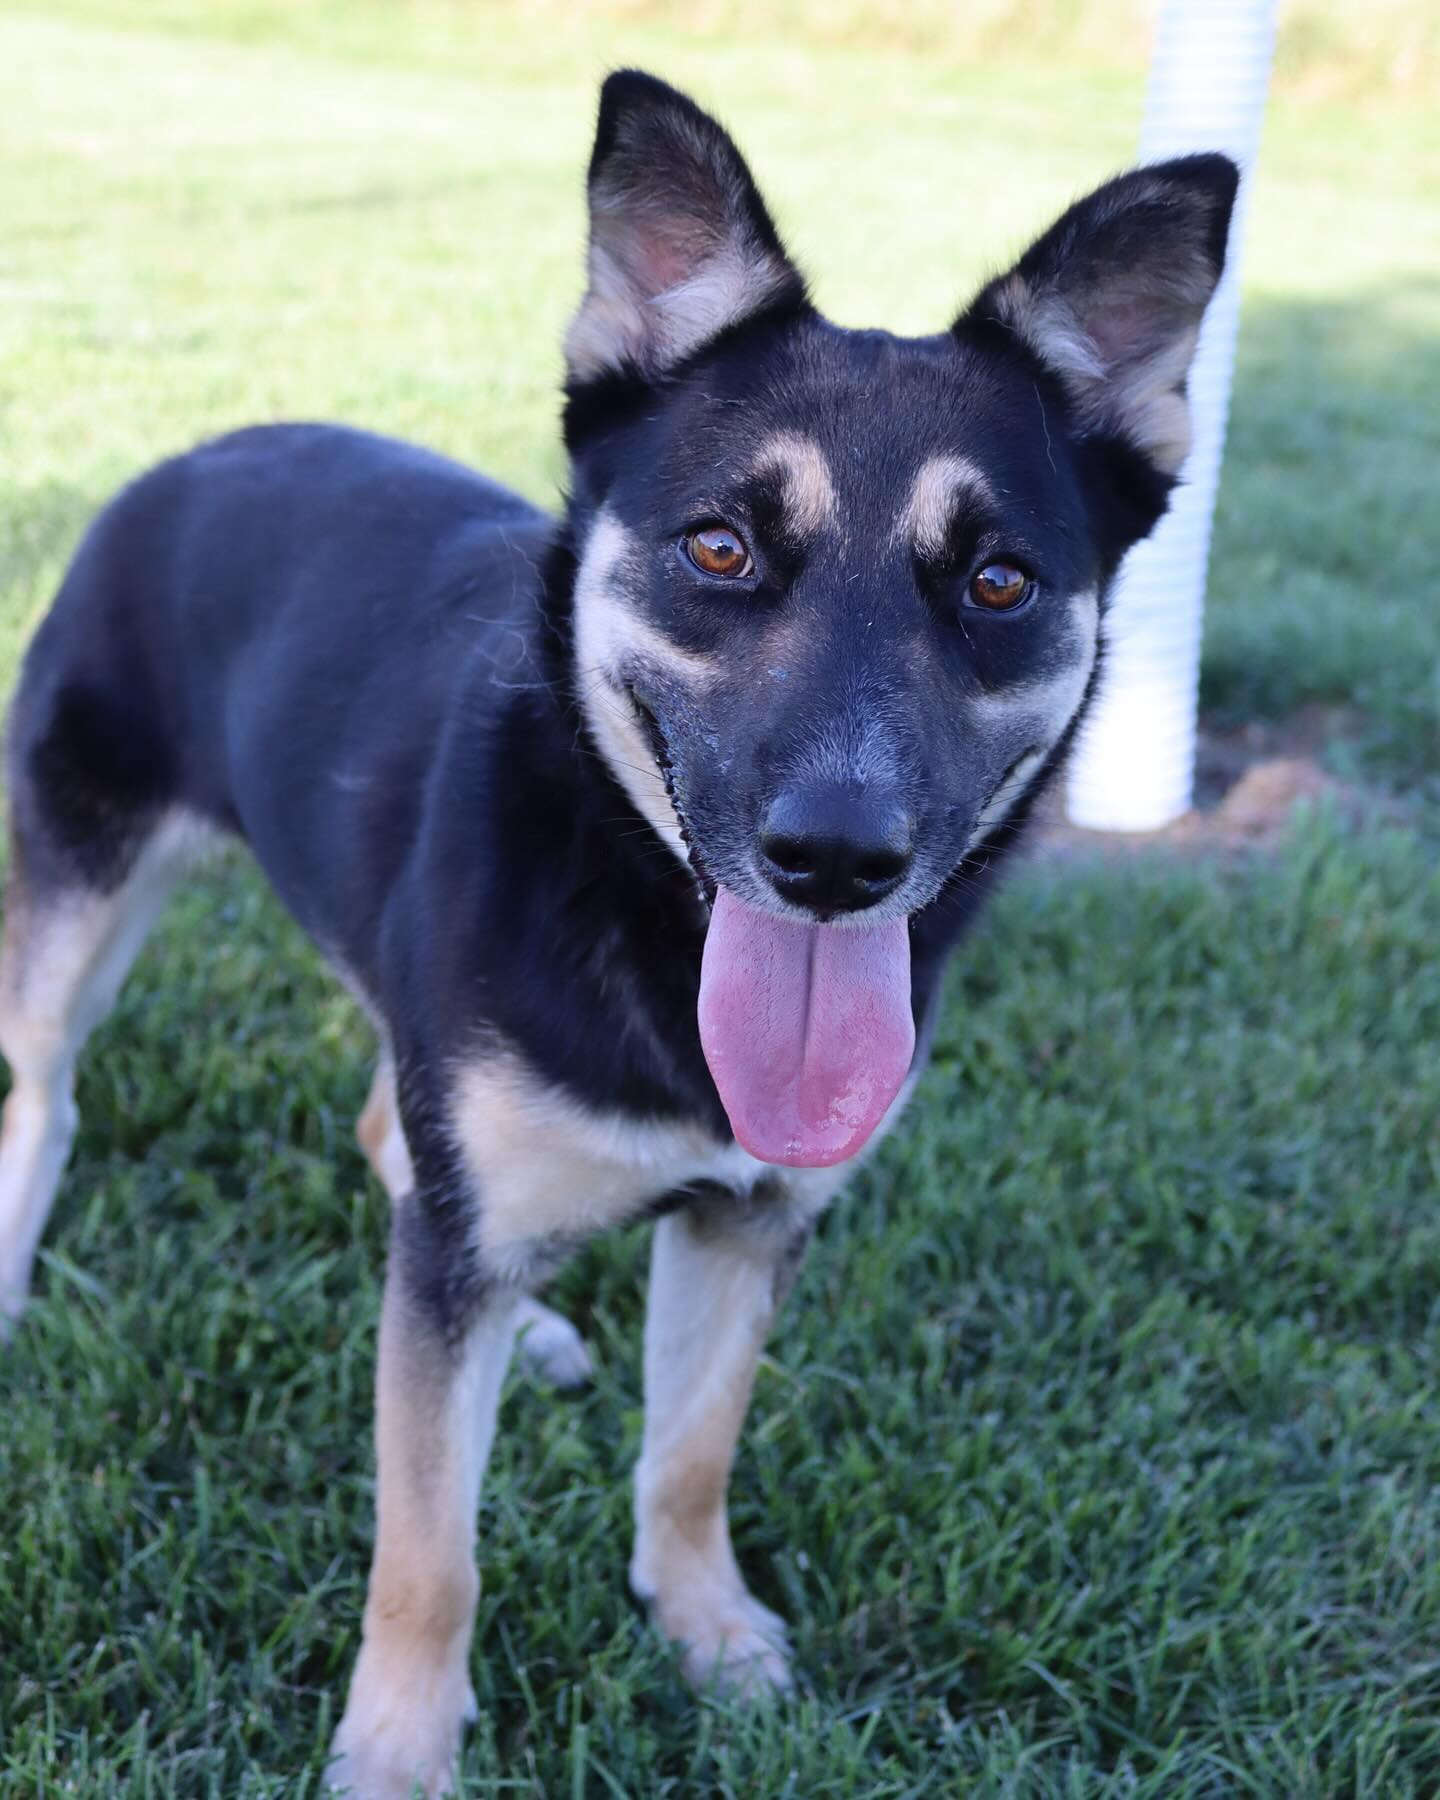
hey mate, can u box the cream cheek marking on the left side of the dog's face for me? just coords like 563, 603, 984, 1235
574, 511, 713, 862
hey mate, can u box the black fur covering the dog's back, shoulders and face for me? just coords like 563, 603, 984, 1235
11, 74, 1233, 1332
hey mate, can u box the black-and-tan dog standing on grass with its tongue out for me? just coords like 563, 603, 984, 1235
0, 70, 1237, 1800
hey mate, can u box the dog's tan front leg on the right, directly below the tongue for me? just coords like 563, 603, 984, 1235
630, 1201, 810, 1692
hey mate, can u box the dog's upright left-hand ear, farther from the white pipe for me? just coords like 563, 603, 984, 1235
565, 68, 805, 383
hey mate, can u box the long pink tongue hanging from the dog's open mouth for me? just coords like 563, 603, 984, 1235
700, 887, 914, 1168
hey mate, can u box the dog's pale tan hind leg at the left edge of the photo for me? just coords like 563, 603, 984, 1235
0, 823, 189, 1334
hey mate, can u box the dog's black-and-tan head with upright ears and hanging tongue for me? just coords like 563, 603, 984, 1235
565, 72, 1237, 1163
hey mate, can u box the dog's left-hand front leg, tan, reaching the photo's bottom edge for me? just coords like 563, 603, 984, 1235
329, 1195, 515, 1800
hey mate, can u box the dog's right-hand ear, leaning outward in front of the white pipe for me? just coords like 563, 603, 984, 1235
959, 155, 1240, 475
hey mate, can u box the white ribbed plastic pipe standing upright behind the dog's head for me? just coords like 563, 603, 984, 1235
1066, 0, 1274, 832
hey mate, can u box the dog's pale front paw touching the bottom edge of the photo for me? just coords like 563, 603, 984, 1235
326, 1667, 477, 1800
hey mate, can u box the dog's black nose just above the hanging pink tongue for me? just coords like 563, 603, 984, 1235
760, 787, 914, 914
